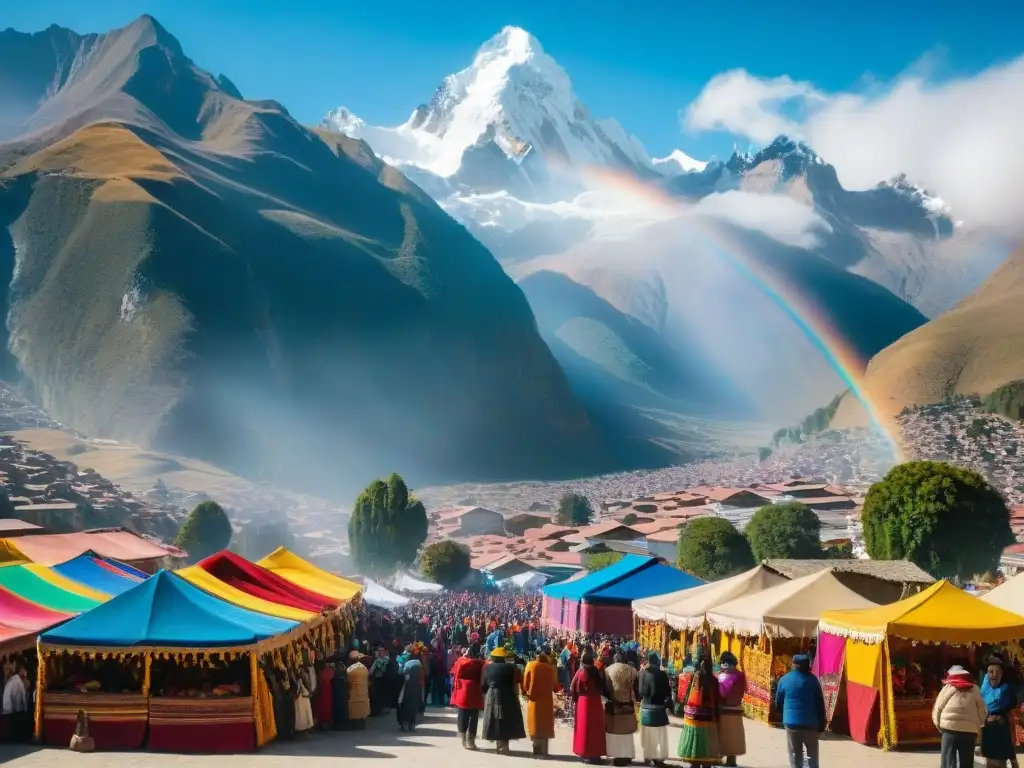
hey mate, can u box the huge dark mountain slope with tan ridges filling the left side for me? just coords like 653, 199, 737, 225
0, 16, 608, 493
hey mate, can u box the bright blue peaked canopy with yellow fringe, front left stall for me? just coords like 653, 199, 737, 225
40, 570, 298, 648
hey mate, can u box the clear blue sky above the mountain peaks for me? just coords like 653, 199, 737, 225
8, 0, 1024, 158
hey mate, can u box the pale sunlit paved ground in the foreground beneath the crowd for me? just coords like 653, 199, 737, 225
0, 708, 958, 768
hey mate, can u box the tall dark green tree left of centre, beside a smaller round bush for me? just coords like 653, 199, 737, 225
348, 474, 427, 575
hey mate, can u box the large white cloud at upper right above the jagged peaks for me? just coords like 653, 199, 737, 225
684, 56, 1024, 232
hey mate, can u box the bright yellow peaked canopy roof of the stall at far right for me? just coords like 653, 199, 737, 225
819, 582, 1024, 644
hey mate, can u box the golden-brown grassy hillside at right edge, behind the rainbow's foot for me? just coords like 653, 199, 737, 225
833, 249, 1024, 427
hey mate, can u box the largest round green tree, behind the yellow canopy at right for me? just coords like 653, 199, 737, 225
861, 462, 1014, 579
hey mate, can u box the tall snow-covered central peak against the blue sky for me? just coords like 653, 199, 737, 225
323, 27, 671, 183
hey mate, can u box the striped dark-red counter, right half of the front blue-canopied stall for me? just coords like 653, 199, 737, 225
150, 696, 256, 753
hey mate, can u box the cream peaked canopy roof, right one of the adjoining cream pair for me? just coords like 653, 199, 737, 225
708, 570, 878, 637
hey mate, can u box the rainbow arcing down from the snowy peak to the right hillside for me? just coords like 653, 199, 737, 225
584, 168, 903, 462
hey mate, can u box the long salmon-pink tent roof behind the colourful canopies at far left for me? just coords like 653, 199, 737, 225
0, 530, 167, 565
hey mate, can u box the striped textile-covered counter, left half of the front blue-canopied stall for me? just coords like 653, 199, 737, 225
43, 691, 150, 750
